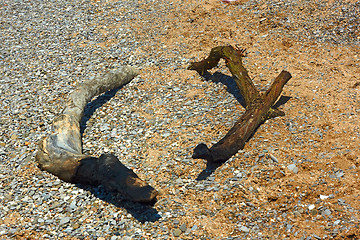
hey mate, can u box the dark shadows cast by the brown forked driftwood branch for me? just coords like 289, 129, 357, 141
194, 72, 291, 181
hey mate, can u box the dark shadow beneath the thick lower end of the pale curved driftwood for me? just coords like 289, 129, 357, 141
76, 184, 161, 223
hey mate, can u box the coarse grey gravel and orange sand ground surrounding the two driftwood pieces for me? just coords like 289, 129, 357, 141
0, 0, 360, 240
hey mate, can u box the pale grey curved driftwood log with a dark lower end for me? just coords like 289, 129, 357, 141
36, 67, 157, 202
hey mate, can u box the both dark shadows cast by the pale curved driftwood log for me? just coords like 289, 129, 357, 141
76, 88, 161, 223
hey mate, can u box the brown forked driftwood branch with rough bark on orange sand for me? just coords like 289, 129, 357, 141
189, 46, 291, 162
